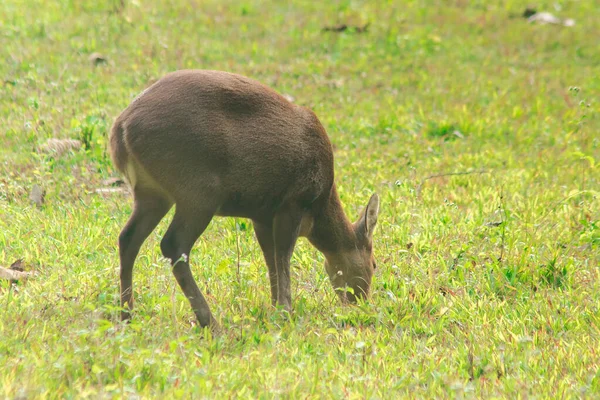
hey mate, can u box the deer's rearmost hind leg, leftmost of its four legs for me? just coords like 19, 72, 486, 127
119, 187, 172, 320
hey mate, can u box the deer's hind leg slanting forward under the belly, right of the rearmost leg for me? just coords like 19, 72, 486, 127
160, 205, 219, 332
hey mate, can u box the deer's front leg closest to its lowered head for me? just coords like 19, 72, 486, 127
273, 208, 302, 312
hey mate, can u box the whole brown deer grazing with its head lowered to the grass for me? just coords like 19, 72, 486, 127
110, 70, 379, 329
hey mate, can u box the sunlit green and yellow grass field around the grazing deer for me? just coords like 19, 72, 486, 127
0, 0, 600, 399
